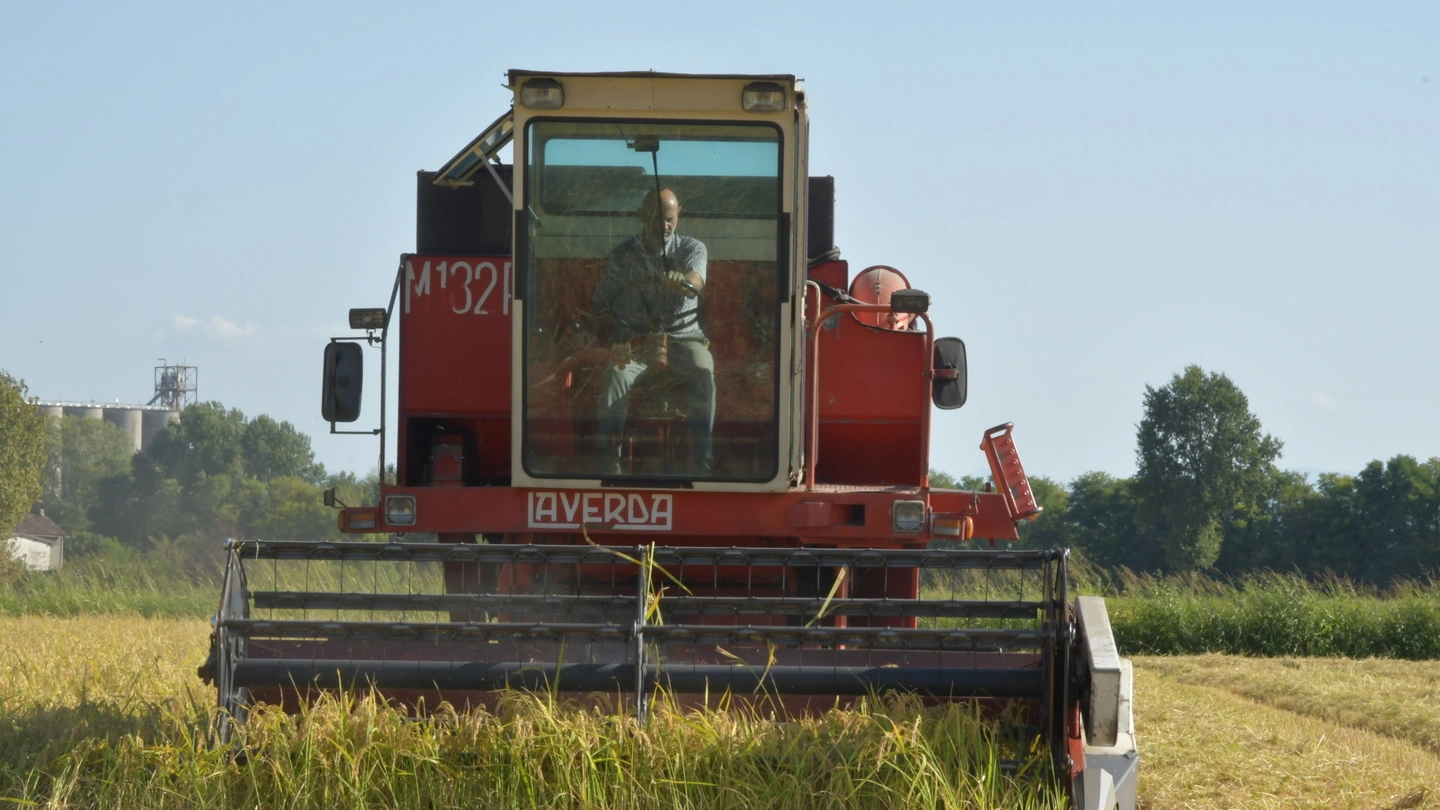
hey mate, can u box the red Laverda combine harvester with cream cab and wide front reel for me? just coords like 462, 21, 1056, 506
202, 71, 1138, 810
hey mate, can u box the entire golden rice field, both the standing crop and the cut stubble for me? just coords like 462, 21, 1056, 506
0, 615, 1440, 810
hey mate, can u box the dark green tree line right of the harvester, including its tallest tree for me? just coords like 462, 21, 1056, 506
979, 366, 1440, 585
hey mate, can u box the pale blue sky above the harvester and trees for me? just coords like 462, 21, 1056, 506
0, 0, 1440, 481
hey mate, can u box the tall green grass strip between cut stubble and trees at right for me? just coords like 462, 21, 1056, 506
1107, 574, 1440, 660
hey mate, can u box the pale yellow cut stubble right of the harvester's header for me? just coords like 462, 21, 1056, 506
1135, 656, 1440, 810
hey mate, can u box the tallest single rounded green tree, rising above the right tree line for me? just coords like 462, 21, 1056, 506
1135, 366, 1282, 571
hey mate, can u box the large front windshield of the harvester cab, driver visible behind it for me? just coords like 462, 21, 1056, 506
517, 121, 780, 481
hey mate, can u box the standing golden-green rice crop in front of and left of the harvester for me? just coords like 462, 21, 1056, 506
0, 617, 1064, 810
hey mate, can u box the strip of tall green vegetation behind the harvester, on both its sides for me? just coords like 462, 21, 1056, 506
8, 548, 1440, 660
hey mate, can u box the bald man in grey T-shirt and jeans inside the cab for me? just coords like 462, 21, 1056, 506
593, 189, 716, 474
